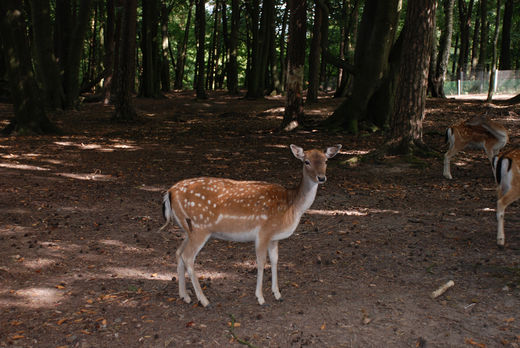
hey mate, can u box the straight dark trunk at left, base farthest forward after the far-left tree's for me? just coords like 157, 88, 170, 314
113, 0, 137, 122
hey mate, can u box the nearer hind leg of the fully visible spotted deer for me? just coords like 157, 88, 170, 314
179, 233, 209, 307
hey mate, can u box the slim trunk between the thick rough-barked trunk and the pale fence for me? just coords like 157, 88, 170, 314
429, 0, 455, 98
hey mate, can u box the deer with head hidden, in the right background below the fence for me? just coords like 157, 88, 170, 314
443, 116, 509, 179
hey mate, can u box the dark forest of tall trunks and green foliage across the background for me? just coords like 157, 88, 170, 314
0, 0, 520, 148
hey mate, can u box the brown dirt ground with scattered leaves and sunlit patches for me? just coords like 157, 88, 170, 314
0, 93, 520, 348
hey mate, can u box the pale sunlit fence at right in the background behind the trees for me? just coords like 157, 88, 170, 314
444, 70, 520, 96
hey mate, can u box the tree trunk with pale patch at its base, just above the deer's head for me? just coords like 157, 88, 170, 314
282, 0, 307, 131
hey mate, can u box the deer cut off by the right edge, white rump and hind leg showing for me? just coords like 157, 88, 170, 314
493, 149, 520, 247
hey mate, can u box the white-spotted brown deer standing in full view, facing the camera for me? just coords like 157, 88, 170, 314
161, 144, 341, 307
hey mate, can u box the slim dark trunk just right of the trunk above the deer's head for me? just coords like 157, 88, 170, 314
306, 0, 323, 103
